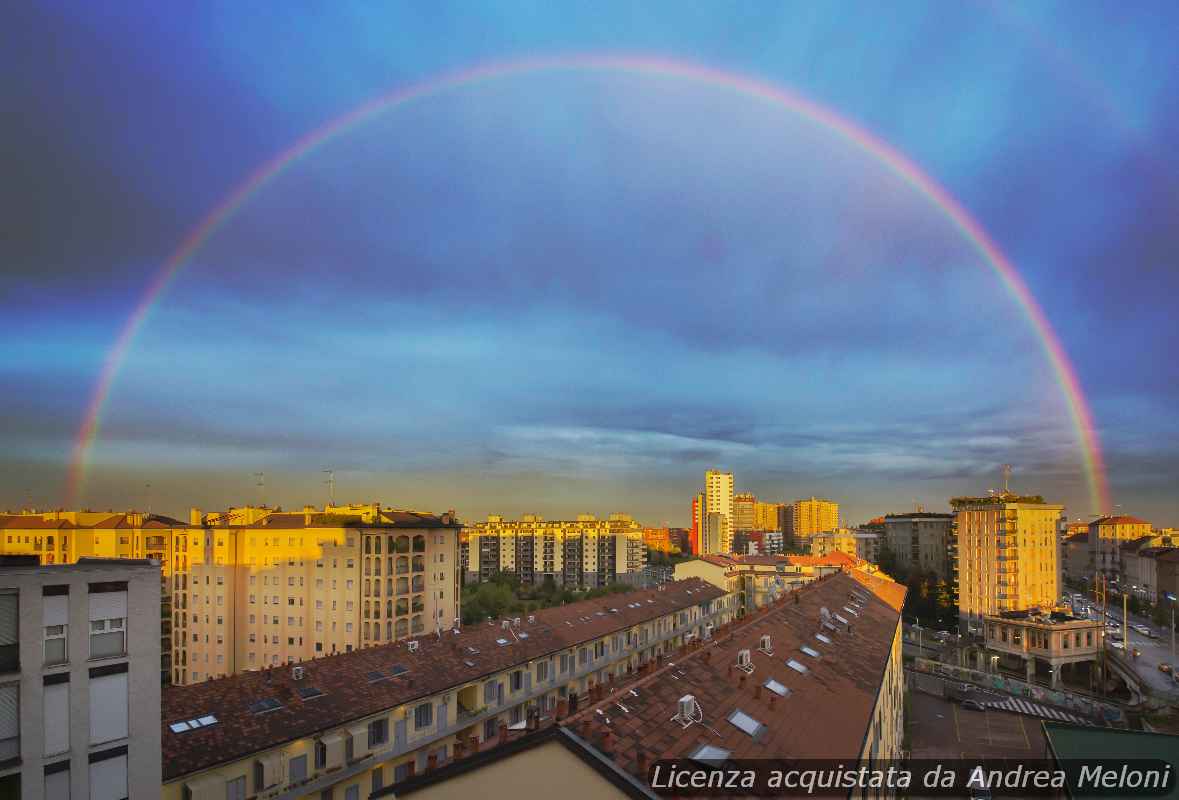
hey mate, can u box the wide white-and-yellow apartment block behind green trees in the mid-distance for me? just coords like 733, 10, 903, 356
460, 514, 647, 589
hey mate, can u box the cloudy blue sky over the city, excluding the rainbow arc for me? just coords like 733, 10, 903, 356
0, 2, 1179, 524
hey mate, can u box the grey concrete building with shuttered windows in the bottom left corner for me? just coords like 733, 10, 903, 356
0, 556, 162, 800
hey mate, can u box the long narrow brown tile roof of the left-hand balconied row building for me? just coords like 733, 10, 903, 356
162, 578, 725, 781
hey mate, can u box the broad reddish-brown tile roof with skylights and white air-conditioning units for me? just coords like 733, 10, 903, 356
565, 570, 905, 780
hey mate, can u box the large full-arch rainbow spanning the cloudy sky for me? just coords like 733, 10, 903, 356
65, 54, 1111, 511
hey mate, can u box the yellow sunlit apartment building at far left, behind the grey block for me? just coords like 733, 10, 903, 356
0, 510, 187, 682
